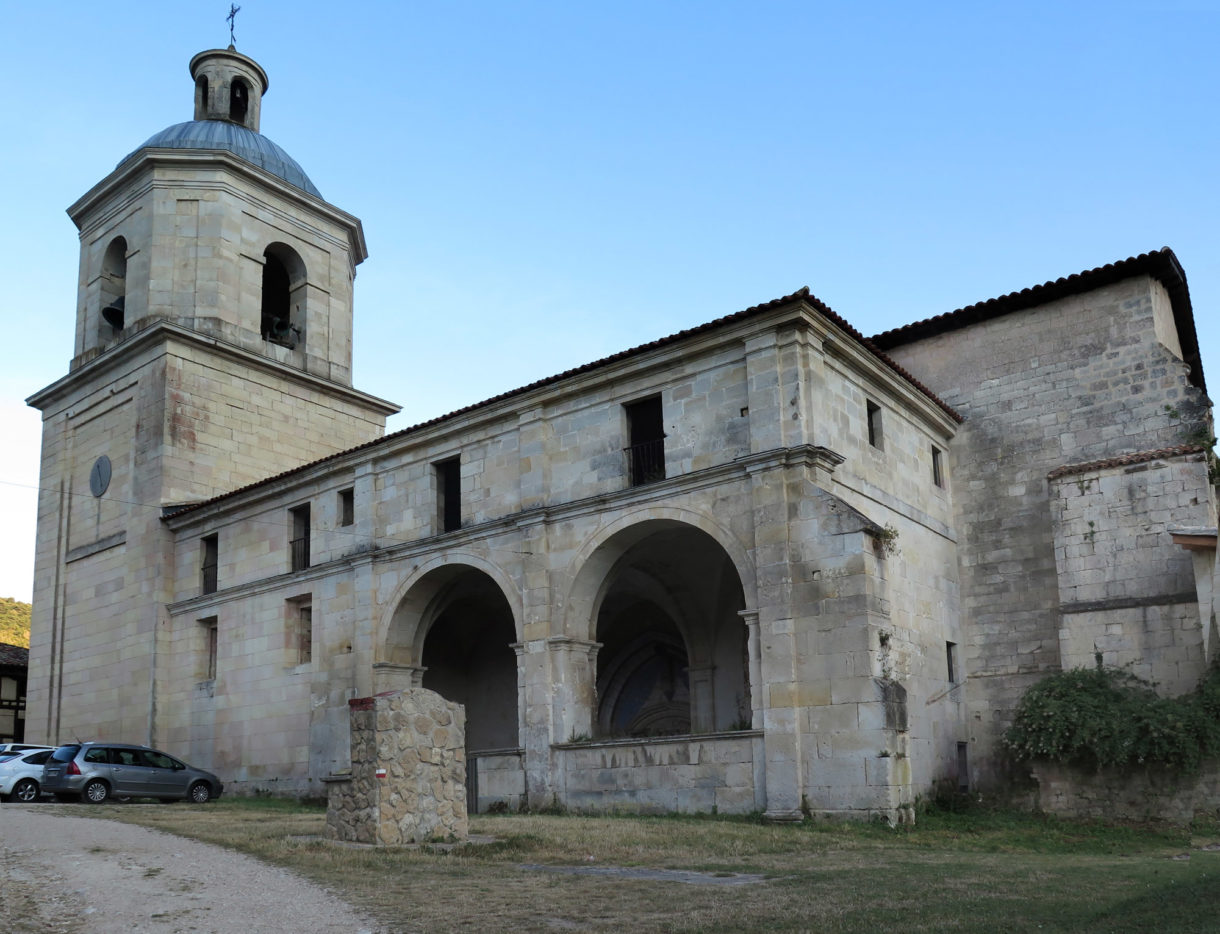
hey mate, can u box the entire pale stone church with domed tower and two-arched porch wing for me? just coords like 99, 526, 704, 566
26, 48, 1218, 819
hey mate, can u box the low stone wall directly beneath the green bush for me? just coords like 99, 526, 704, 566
1032, 762, 1220, 824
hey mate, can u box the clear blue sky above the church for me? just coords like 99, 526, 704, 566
0, 0, 1220, 600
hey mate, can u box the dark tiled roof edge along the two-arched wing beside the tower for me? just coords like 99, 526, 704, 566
162, 285, 963, 518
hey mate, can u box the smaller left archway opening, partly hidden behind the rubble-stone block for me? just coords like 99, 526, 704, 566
384, 565, 520, 756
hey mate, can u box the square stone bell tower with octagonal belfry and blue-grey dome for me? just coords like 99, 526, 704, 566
27, 48, 398, 743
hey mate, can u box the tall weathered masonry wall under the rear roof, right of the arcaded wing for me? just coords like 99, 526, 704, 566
888, 277, 1208, 784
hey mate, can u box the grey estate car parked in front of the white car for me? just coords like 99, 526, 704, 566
43, 743, 224, 805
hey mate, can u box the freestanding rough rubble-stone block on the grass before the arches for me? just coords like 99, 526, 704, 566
326, 688, 468, 845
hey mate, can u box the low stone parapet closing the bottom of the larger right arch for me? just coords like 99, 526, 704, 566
555, 730, 766, 815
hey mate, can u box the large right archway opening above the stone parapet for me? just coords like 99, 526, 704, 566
594, 523, 750, 738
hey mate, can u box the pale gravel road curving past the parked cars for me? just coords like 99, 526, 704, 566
0, 805, 382, 934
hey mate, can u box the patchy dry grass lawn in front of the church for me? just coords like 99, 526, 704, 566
65, 799, 1220, 934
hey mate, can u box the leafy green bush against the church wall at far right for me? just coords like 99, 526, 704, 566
1004, 665, 1220, 772
